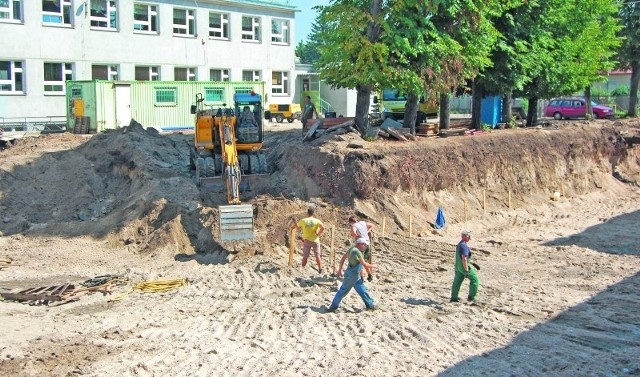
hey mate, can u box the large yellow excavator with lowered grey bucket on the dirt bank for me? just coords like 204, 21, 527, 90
190, 93, 268, 241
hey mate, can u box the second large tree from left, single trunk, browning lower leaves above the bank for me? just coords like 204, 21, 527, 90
383, 0, 501, 133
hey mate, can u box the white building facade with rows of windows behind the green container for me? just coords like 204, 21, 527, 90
0, 0, 299, 121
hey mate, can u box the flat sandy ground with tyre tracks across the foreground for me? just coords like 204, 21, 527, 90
0, 180, 640, 376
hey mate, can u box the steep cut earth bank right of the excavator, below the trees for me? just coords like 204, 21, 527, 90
276, 121, 640, 229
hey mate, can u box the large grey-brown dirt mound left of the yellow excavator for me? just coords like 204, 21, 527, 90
0, 126, 205, 256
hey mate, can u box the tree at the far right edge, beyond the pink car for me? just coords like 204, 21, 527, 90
618, 1, 640, 117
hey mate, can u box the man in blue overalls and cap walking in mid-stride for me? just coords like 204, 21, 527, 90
329, 238, 376, 312
